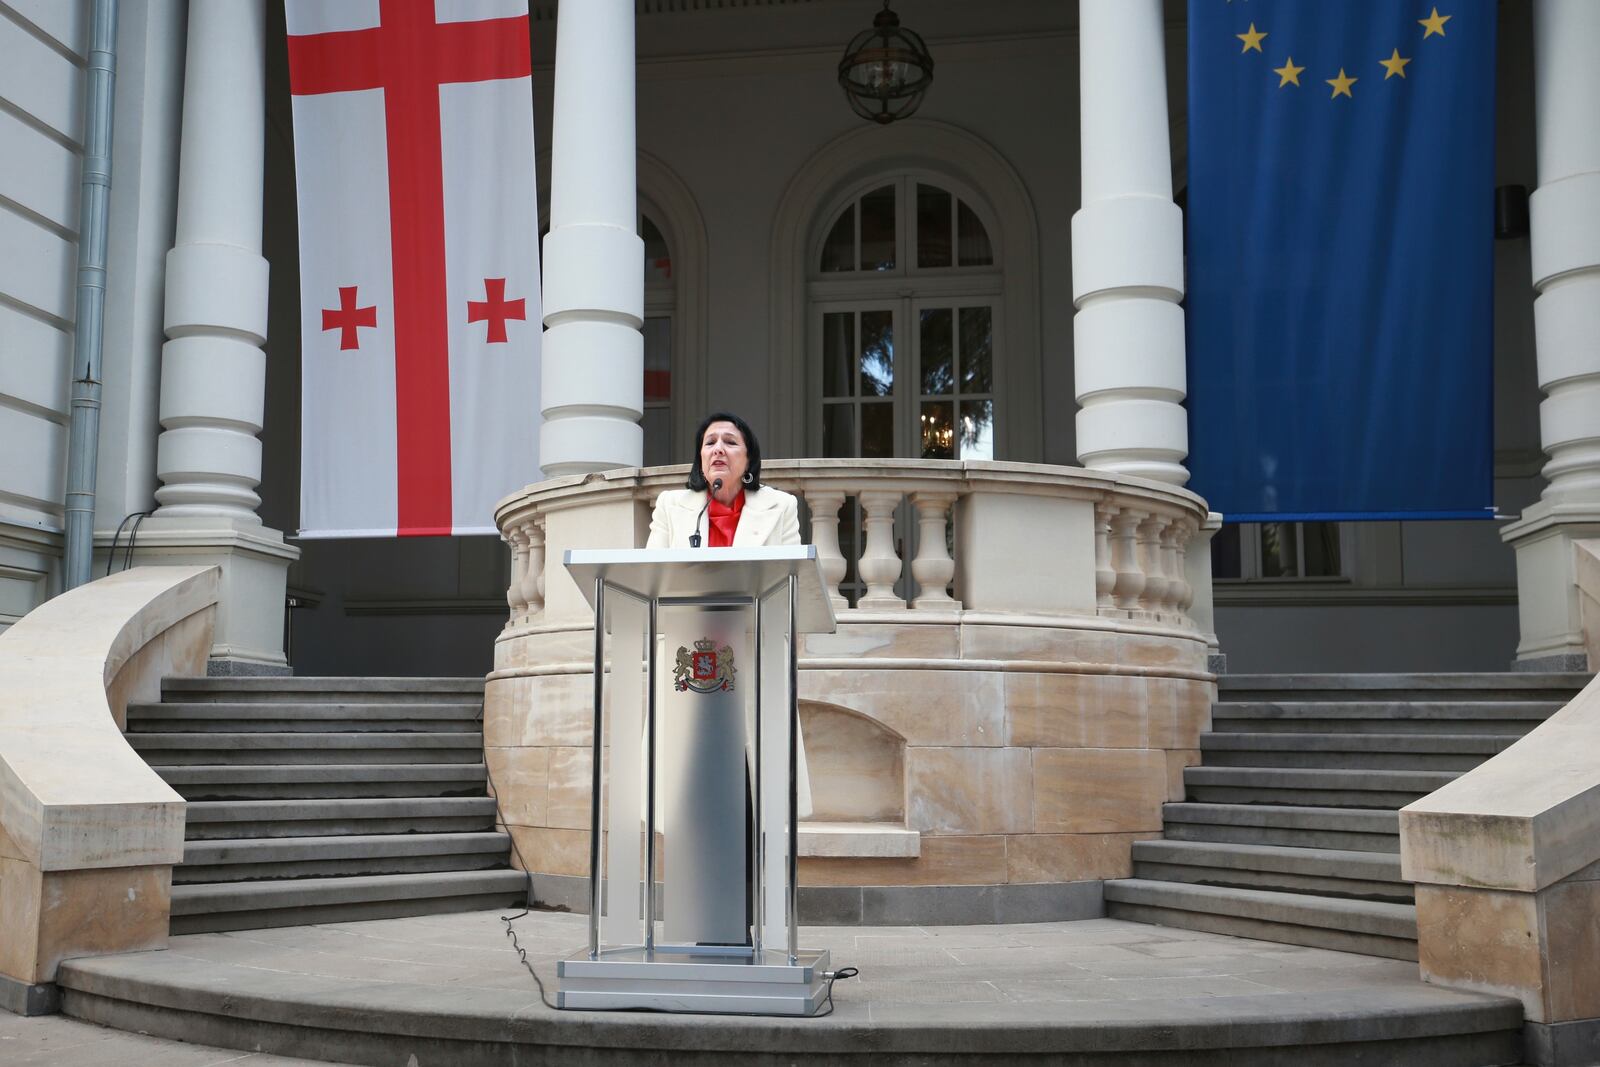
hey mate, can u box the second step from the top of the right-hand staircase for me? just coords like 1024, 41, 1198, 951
1211, 701, 1565, 734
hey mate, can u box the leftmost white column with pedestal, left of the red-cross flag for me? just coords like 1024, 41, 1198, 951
139, 0, 299, 673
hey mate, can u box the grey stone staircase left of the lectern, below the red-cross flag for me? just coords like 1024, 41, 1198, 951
128, 678, 528, 934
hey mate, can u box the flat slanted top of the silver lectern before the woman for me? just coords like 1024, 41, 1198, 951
563, 544, 837, 633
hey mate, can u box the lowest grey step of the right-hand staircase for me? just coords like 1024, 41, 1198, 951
1106, 878, 1416, 960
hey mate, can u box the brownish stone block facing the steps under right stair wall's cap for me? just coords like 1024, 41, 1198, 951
1416, 885, 1550, 1022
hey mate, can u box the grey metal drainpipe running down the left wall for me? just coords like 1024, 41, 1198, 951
64, 0, 117, 589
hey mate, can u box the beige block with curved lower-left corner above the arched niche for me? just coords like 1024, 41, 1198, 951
800, 669, 1005, 747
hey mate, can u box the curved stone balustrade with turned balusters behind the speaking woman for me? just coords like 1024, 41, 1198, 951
498, 459, 1210, 630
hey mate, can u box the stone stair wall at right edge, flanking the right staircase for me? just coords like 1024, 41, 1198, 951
1400, 541, 1600, 1065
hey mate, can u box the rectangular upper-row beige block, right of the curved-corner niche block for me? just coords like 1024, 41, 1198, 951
1005, 673, 1165, 749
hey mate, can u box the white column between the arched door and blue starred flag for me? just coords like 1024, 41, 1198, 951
1072, 0, 1189, 485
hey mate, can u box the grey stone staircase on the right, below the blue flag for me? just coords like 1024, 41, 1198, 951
1106, 673, 1589, 960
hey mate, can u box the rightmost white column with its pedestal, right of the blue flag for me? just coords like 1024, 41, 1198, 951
1504, 0, 1600, 670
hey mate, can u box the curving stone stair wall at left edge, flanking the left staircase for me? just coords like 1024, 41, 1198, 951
0, 566, 219, 1014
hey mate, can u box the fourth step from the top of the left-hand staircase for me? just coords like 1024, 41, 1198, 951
157, 763, 488, 801
